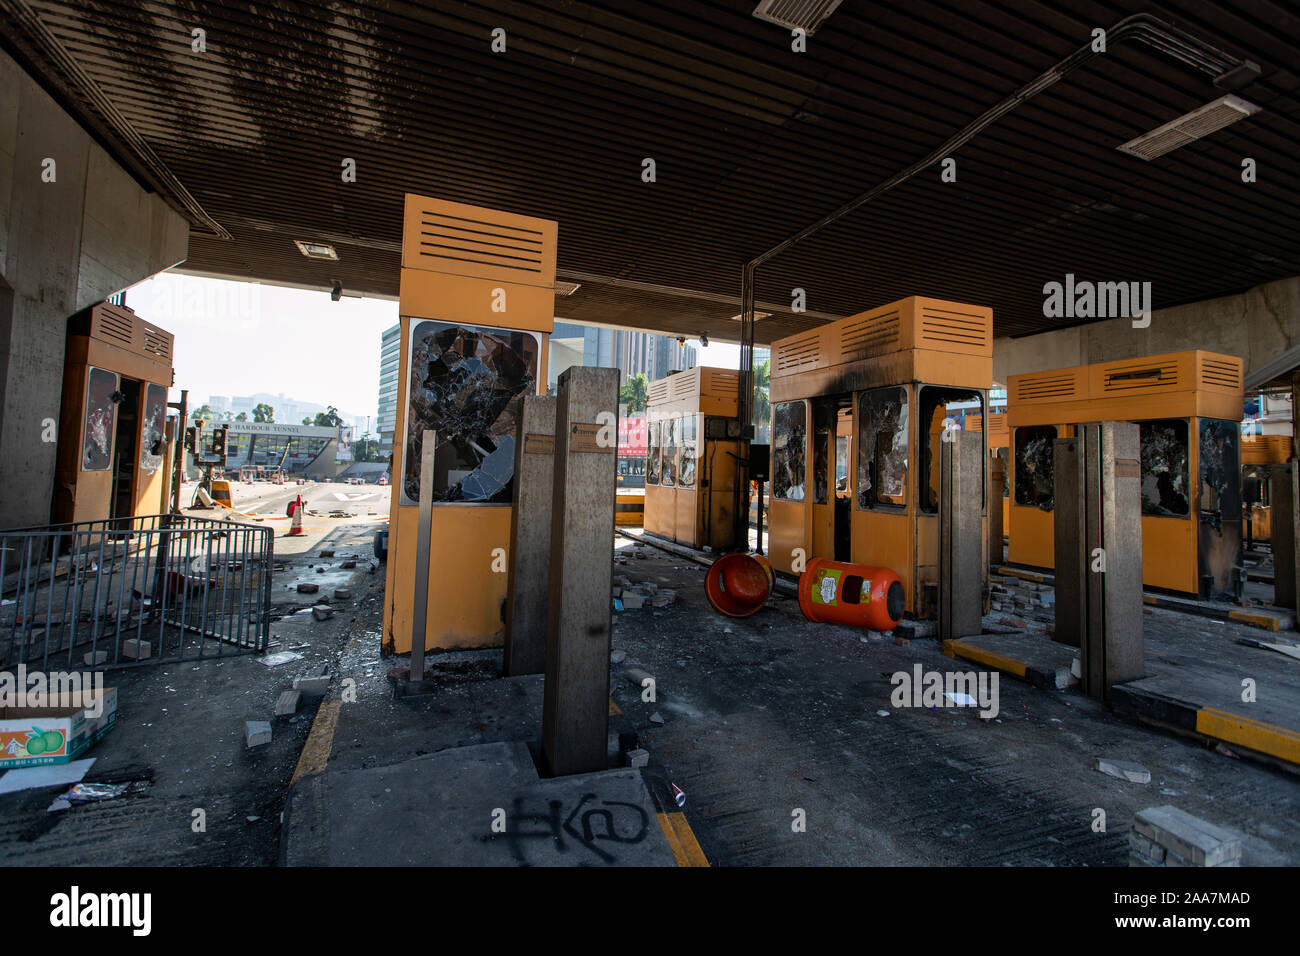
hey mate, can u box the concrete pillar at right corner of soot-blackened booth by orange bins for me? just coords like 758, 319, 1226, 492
939, 429, 984, 640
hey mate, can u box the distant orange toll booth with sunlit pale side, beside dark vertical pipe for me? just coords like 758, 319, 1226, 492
645, 367, 740, 550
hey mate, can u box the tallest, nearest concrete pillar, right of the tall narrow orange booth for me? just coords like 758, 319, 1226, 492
542, 365, 619, 775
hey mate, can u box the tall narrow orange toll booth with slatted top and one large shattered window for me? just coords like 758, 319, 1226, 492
384, 195, 556, 654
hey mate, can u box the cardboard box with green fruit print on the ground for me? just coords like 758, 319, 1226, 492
0, 687, 117, 770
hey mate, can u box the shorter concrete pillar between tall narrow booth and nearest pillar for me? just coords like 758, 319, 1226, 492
503, 395, 555, 676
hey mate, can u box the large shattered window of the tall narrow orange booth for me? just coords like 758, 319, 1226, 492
402, 320, 538, 505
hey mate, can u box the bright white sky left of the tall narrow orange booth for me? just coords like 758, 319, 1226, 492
126, 272, 398, 424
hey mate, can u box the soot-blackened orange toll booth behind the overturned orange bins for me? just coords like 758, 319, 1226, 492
768, 297, 993, 618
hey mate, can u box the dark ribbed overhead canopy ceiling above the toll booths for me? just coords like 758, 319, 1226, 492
0, 0, 1300, 343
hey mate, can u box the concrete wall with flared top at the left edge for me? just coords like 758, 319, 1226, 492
0, 52, 190, 528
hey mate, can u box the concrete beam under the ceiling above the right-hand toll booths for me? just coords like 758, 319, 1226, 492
993, 277, 1300, 385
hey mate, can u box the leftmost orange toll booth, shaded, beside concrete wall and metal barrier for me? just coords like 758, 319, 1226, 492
51, 302, 173, 524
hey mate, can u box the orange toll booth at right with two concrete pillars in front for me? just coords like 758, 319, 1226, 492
1008, 350, 1243, 598
